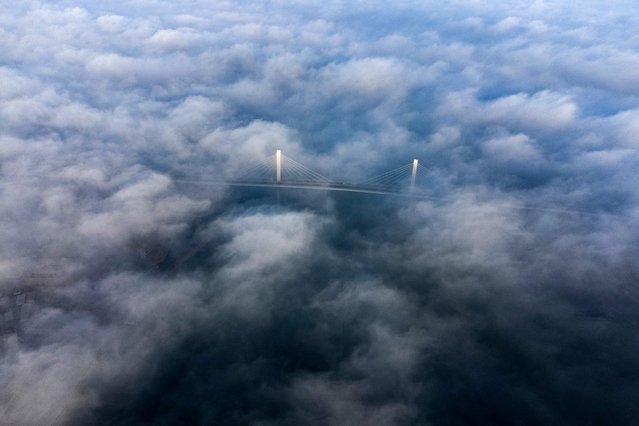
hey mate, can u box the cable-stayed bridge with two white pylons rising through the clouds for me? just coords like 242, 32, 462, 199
174, 149, 425, 196
